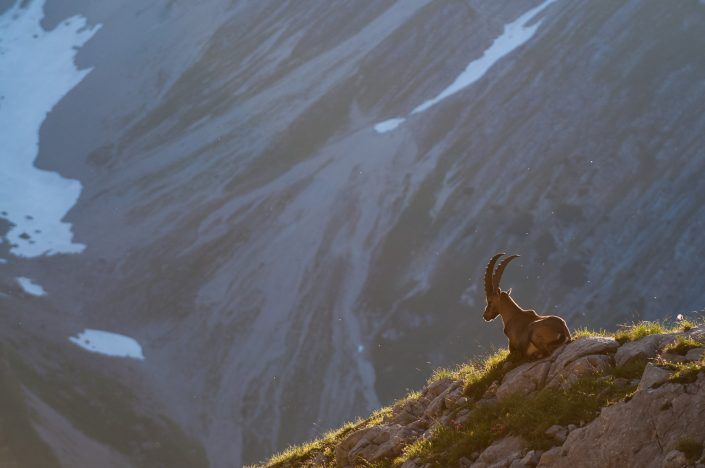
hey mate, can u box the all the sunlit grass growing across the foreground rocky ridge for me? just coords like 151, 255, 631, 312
263, 320, 705, 467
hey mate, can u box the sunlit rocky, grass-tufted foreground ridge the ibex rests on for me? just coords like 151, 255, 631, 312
268, 325, 705, 468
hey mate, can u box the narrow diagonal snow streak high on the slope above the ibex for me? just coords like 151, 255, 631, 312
374, 0, 556, 133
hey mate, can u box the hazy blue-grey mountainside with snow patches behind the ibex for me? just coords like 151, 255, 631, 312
0, 0, 705, 467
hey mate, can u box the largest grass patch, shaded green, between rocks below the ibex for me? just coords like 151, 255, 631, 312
394, 376, 635, 467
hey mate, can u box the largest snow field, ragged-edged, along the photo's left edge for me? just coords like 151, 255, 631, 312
0, 0, 99, 257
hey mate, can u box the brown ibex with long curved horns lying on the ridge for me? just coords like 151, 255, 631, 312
483, 253, 571, 358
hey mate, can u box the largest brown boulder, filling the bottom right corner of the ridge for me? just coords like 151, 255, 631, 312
556, 373, 705, 467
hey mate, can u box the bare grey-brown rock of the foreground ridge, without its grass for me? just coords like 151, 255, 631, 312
322, 326, 705, 468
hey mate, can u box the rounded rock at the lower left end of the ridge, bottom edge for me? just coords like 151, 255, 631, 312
335, 424, 419, 467
